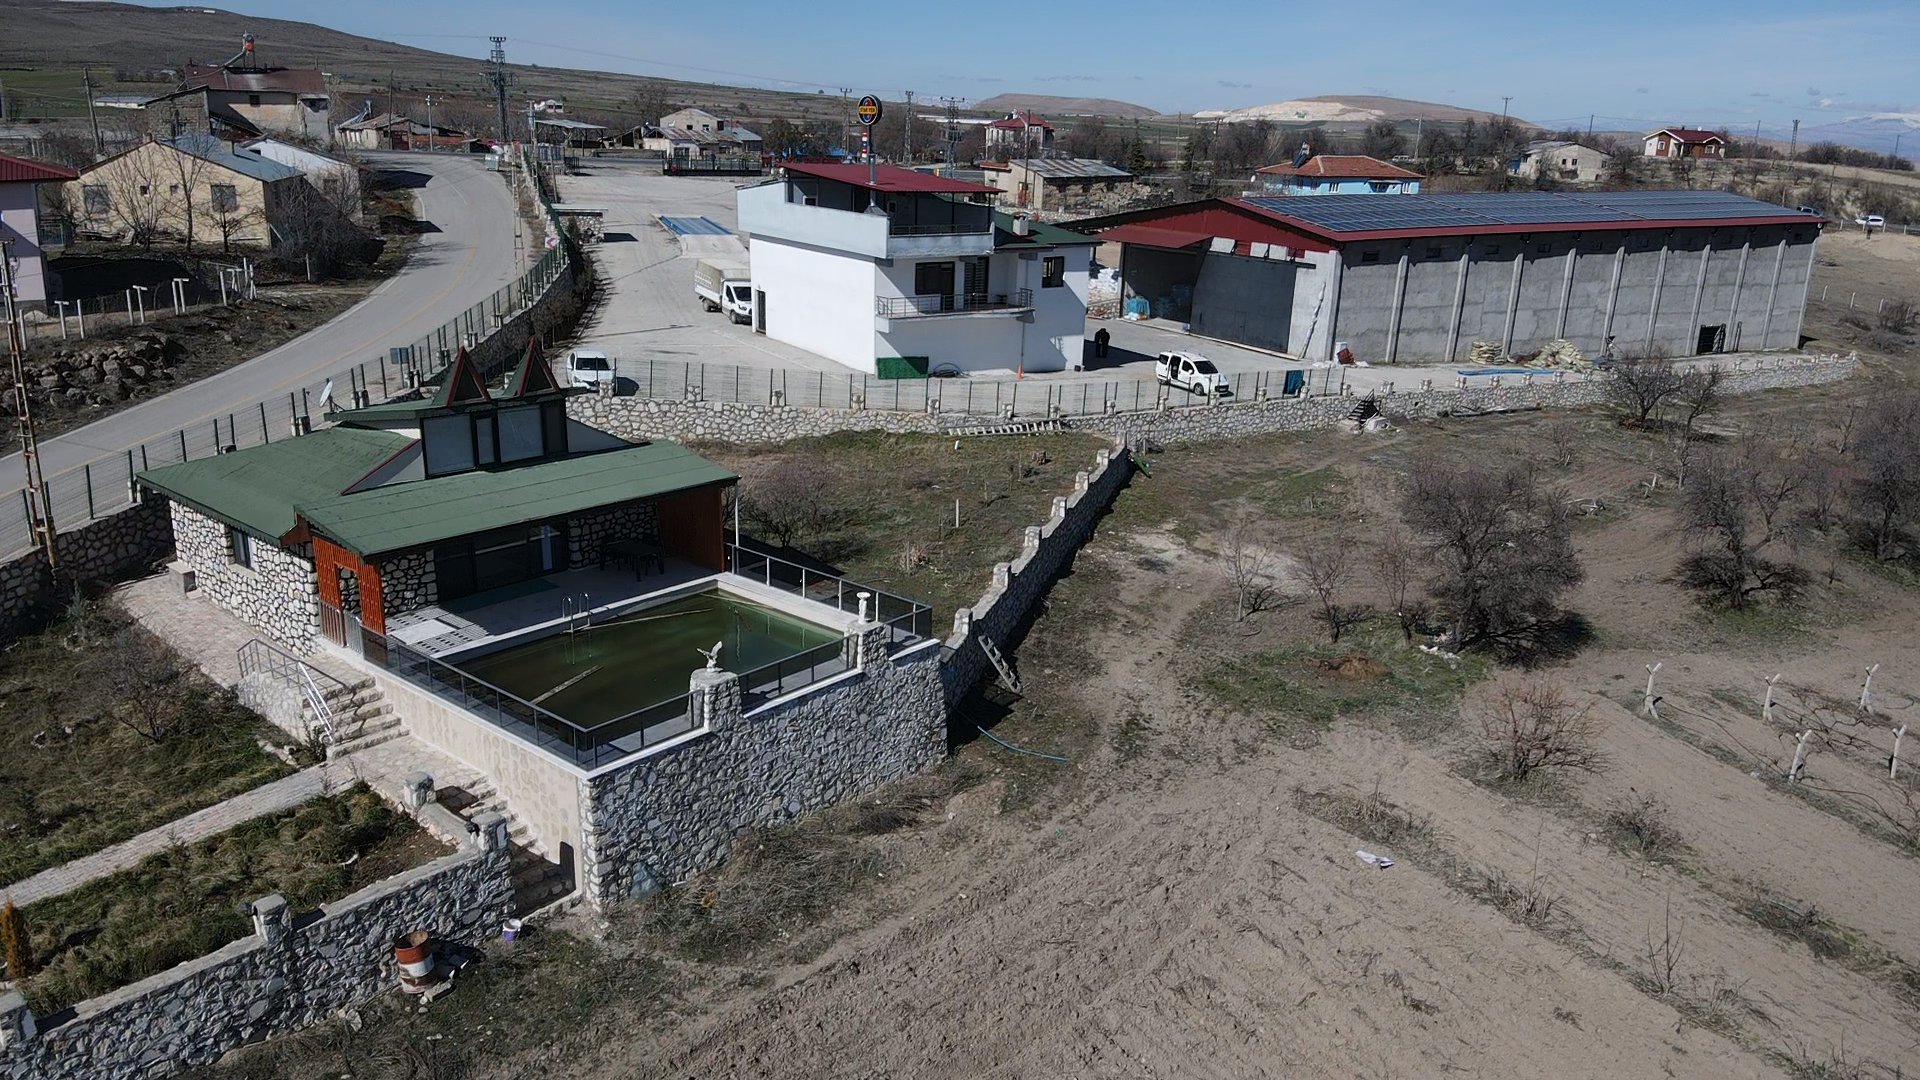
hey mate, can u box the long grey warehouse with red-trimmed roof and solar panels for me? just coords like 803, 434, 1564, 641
1073, 190, 1822, 363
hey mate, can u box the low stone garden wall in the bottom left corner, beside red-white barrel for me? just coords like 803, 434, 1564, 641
0, 803, 513, 1080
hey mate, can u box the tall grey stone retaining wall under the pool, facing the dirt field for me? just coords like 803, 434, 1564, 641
580, 626, 947, 905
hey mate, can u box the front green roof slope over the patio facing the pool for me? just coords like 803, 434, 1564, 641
300, 440, 735, 555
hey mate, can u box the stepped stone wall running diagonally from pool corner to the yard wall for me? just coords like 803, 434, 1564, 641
941, 440, 1128, 707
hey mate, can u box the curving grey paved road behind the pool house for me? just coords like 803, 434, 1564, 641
0, 154, 522, 492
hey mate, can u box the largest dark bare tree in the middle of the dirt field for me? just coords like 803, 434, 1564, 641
1402, 463, 1584, 650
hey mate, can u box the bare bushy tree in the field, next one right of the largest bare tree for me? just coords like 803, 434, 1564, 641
1680, 440, 1809, 607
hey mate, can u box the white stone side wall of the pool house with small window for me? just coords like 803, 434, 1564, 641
173, 503, 321, 653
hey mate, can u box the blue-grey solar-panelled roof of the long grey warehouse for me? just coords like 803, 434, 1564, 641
1227, 190, 1807, 238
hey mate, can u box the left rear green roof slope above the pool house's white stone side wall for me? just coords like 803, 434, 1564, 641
140, 427, 413, 540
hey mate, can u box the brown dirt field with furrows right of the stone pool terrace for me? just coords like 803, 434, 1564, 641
191, 203, 1920, 1080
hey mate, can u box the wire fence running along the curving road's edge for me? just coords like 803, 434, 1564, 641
0, 156, 570, 559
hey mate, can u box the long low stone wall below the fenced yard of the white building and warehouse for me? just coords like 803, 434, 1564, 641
566, 354, 1859, 444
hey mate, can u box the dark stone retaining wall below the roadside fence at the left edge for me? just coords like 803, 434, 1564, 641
0, 494, 173, 640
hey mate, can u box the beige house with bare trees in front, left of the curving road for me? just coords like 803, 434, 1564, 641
65, 133, 305, 246
